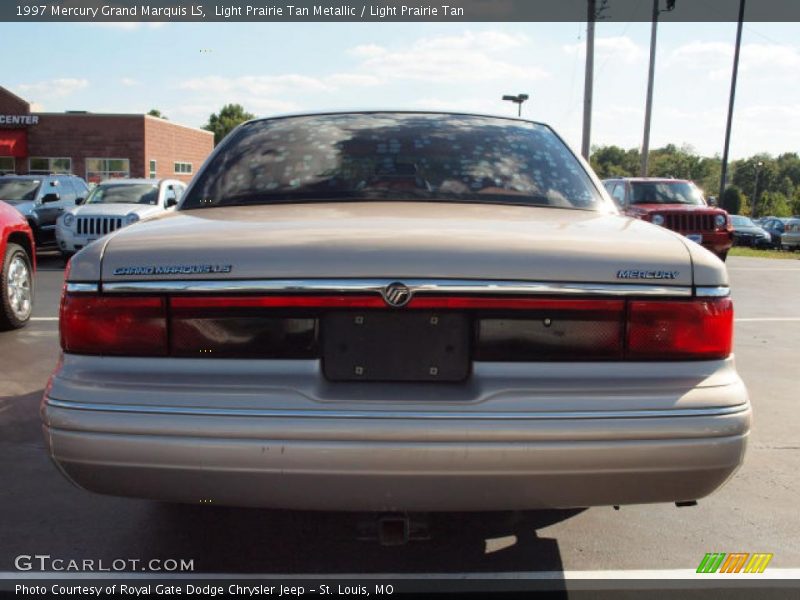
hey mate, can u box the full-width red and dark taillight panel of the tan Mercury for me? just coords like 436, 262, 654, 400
60, 293, 733, 361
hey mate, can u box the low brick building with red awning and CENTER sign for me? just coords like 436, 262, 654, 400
0, 87, 214, 182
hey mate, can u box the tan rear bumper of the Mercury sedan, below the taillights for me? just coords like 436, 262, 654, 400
42, 361, 751, 511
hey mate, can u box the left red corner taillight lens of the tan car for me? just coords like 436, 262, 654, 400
60, 294, 167, 356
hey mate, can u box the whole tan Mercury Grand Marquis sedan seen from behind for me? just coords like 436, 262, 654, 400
42, 112, 751, 511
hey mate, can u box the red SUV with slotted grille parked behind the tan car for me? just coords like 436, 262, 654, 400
603, 177, 733, 260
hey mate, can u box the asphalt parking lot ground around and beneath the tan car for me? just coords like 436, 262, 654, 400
0, 255, 800, 574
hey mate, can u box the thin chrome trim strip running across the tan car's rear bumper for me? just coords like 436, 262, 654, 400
46, 398, 749, 421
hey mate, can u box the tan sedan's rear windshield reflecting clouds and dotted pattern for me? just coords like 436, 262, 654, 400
181, 113, 603, 210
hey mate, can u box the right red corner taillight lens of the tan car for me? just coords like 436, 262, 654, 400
627, 298, 733, 360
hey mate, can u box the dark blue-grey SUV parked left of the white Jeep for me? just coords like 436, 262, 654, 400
0, 175, 89, 246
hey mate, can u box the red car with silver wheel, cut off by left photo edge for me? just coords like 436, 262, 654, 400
0, 202, 36, 330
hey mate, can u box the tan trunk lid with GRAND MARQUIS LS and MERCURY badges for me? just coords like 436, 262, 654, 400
102, 202, 692, 286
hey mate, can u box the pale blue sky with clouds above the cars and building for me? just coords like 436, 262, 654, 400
0, 22, 800, 158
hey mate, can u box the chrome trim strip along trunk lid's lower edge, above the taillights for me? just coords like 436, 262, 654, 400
102, 278, 692, 298
